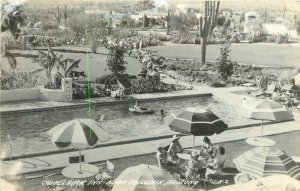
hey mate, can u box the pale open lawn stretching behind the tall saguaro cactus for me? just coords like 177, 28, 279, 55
147, 43, 300, 67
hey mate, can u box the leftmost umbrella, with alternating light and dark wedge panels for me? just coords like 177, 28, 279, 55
47, 119, 111, 171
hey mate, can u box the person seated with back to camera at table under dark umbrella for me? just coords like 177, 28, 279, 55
185, 150, 200, 180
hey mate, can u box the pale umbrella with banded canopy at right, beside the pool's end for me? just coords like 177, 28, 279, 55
243, 99, 293, 139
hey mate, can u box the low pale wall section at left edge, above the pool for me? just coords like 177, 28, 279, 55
0, 88, 40, 102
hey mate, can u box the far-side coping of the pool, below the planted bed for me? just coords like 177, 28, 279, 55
0, 90, 213, 115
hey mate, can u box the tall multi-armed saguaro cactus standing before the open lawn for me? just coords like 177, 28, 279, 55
199, 1, 220, 63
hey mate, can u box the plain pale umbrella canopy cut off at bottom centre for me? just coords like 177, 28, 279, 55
112, 164, 179, 191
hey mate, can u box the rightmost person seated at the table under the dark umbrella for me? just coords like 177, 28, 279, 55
205, 147, 225, 180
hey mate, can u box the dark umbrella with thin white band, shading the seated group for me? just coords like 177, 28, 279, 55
169, 107, 228, 149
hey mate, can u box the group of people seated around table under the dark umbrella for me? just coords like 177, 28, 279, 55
156, 135, 225, 180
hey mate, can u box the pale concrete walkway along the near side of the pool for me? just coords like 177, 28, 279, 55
0, 121, 300, 176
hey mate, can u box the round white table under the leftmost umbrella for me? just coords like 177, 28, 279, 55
62, 163, 99, 179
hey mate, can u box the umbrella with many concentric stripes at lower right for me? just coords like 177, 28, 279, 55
233, 147, 300, 178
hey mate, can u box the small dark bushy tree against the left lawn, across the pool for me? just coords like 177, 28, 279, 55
106, 44, 127, 78
